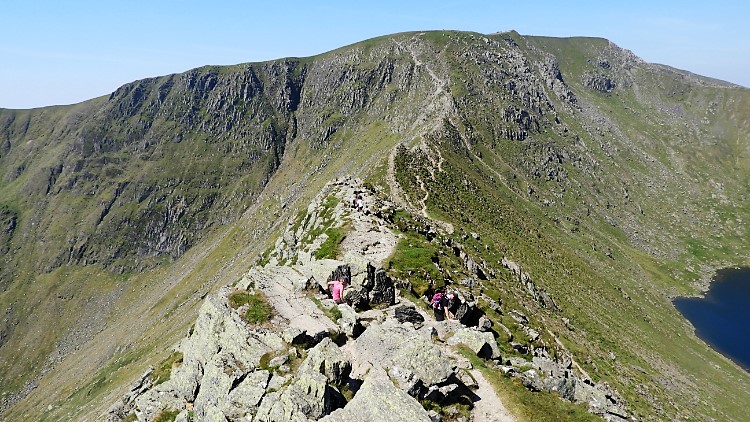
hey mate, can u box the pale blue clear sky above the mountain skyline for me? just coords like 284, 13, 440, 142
0, 0, 750, 108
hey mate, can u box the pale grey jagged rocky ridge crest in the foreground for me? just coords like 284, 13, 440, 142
106, 178, 628, 421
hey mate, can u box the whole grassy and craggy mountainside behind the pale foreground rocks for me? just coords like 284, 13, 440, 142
0, 31, 750, 421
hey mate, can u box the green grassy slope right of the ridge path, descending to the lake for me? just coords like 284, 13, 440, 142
390, 31, 750, 420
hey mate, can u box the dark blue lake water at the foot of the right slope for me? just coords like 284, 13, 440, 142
674, 268, 750, 372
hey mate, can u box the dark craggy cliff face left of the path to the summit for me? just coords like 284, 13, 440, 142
2, 41, 446, 278
